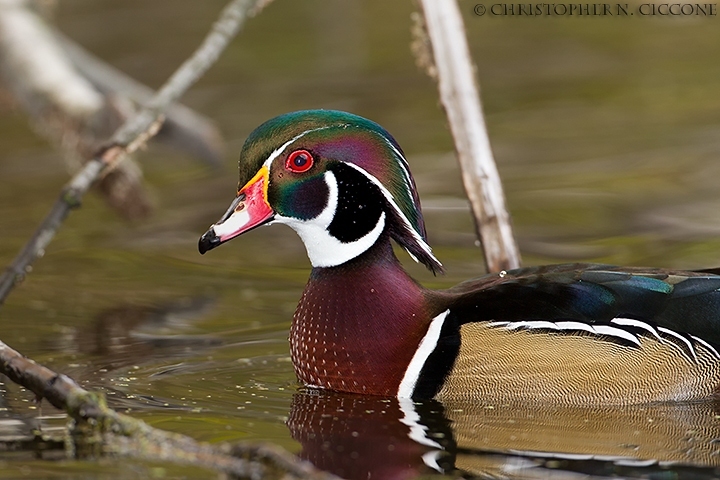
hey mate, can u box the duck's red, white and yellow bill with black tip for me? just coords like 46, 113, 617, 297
198, 167, 275, 254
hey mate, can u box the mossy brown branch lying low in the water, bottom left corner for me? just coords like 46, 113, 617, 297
0, 341, 336, 480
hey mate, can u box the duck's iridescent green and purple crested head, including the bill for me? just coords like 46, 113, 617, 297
199, 110, 442, 272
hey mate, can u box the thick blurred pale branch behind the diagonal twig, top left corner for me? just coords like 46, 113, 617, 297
0, 0, 151, 219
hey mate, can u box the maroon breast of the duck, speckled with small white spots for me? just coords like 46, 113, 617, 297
291, 264, 429, 395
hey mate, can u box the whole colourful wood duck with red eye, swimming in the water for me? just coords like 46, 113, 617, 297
199, 110, 720, 405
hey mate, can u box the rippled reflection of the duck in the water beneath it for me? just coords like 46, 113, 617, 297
288, 390, 720, 479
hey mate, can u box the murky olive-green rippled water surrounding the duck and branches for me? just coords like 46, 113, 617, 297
0, 0, 720, 478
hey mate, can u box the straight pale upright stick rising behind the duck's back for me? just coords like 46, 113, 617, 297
414, 0, 520, 272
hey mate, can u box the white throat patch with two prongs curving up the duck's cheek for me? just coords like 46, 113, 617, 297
275, 171, 385, 267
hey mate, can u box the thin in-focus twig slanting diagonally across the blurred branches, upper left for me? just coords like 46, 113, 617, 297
0, 0, 267, 305
